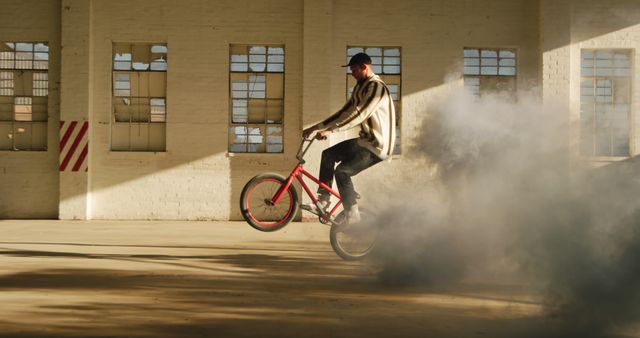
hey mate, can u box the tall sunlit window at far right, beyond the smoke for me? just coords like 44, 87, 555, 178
580, 50, 631, 156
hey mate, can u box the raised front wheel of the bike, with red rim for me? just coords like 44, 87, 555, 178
240, 174, 298, 231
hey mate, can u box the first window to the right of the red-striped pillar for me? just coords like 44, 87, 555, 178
111, 43, 168, 151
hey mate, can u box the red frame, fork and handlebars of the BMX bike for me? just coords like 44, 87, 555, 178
271, 138, 342, 223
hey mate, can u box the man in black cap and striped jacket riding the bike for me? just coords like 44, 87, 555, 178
303, 53, 396, 224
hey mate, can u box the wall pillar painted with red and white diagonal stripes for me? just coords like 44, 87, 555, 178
59, 0, 93, 219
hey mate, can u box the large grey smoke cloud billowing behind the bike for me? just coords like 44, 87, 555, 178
373, 88, 640, 337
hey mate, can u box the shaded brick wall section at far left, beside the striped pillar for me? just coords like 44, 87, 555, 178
0, 0, 60, 218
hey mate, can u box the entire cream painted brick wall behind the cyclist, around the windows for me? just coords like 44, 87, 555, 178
5, 0, 640, 220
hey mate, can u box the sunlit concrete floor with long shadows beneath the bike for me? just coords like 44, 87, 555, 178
0, 220, 632, 337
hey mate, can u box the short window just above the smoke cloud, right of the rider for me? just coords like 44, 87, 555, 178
463, 48, 517, 97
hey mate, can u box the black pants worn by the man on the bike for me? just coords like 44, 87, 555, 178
318, 139, 382, 208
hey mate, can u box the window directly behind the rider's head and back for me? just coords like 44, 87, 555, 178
347, 47, 402, 155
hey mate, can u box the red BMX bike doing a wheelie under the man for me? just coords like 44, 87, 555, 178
240, 138, 379, 260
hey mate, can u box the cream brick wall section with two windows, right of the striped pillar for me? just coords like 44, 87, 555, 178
91, 0, 303, 219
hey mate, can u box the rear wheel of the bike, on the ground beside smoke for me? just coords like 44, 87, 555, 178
330, 209, 380, 261
